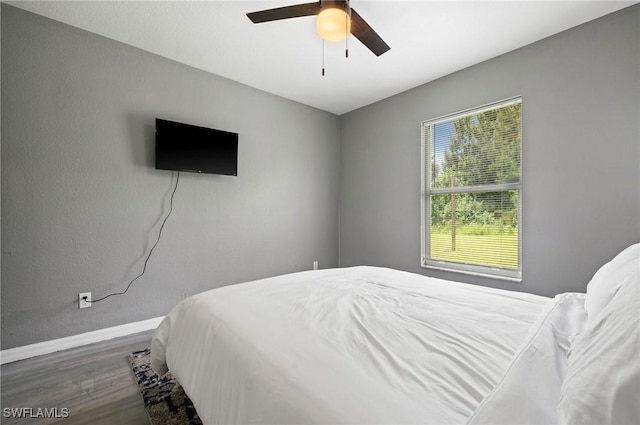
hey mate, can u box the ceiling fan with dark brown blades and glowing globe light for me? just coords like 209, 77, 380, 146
247, 0, 390, 56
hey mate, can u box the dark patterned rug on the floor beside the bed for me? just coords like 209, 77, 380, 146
129, 348, 202, 425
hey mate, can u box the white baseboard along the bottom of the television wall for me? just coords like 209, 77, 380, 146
0, 317, 164, 364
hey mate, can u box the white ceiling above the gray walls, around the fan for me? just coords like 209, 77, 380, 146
7, 0, 638, 115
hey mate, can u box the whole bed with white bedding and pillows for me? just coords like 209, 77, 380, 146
151, 244, 640, 425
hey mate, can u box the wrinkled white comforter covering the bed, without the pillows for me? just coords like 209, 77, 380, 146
152, 267, 584, 424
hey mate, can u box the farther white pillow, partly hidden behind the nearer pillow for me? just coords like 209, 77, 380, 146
584, 244, 640, 321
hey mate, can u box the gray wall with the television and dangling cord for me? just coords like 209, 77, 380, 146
1, 4, 339, 349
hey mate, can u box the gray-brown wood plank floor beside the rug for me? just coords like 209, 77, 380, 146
0, 331, 152, 425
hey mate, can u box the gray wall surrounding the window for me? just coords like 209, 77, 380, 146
339, 5, 640, 295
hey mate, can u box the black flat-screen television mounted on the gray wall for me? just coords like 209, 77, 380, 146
156, 118, 238, 176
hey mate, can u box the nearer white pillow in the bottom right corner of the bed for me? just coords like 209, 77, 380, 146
557, 250, 640, 425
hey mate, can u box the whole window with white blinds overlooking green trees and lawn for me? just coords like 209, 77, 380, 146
422, 98, 522, 281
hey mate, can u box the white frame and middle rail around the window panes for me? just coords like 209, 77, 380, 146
420, 96, 524, 282
